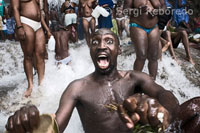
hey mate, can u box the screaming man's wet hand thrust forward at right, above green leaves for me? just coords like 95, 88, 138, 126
118, 94, 170, 128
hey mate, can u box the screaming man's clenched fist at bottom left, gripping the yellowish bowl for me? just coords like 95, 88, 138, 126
6, 105, 39, 133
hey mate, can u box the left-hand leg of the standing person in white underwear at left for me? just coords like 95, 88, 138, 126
20, 24, 35, 97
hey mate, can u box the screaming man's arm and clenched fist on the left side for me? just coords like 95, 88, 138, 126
6, 81, 81, 133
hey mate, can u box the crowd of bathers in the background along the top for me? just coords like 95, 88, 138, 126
0, 0, 200, 72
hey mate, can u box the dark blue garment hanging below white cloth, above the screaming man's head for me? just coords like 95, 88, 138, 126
98, 8, 113, 29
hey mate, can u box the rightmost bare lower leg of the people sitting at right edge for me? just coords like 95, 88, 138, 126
180, 30, 195, 65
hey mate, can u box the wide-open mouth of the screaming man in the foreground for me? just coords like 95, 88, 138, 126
97, 54, 110, 69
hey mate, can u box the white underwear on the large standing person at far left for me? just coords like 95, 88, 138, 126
20, 16, 42, 31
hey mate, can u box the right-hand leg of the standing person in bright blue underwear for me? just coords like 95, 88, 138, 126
147, 27, 161, 79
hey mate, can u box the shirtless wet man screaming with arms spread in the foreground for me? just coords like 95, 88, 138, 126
7, 29, 179, 133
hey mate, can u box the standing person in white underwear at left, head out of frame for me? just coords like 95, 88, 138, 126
11, 0, 51, 97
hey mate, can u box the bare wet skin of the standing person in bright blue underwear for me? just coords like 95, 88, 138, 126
124, 0, 166, 79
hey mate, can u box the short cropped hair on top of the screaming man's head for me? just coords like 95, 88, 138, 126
92, 28, 120, 46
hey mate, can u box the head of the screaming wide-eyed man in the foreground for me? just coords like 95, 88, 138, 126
90, 28, 121, 74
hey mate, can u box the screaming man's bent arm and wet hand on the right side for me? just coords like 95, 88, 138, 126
118, 71, 179, 128
